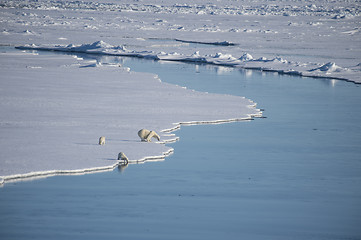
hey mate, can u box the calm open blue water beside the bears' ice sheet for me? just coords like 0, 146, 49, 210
0, 53, 361, 239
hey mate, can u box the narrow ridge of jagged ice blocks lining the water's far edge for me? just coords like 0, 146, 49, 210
17, 41, 361, 82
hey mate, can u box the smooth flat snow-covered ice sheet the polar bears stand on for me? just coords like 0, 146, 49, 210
0, 50, 261, 181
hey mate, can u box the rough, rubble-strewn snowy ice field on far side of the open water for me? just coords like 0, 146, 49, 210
0, 0, 361, 83
